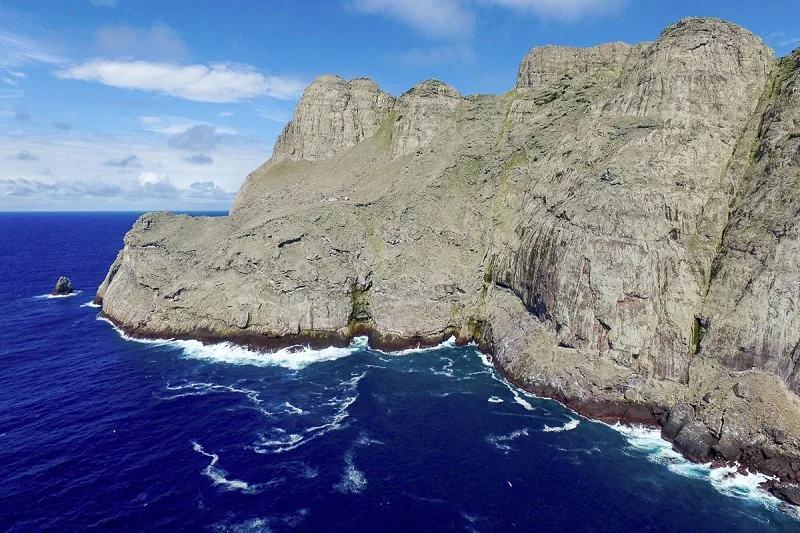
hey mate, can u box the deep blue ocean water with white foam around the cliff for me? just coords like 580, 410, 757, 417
0, 213, 800, 533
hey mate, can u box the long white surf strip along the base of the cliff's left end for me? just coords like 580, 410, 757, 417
98, 316, 358, 370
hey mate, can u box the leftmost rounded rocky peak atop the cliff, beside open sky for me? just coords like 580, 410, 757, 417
272, 75, 394, 161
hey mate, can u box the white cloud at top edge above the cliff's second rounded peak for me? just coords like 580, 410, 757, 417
352, 0, 475, 38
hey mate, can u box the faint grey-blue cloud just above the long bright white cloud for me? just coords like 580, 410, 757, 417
92, 24, 189, 61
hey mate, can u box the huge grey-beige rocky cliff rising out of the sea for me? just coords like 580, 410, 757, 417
97, 19, 800, 498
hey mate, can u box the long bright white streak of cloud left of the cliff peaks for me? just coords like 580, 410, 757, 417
55, 59, 305, 103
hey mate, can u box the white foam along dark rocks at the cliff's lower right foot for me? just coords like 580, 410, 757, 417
610, 424, 786, 510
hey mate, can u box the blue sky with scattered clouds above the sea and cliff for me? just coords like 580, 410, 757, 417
0, 0, 800, 211
